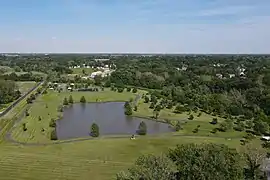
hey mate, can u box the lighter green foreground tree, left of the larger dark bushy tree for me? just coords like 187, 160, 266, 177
116, 155, 176, 180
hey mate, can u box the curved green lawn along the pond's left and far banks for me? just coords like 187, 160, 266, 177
12, 89, 141, 143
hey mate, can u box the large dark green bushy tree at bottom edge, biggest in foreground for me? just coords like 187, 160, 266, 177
168, 144, 243, 180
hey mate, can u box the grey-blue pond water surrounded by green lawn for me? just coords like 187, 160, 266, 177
57, 102, 172, 140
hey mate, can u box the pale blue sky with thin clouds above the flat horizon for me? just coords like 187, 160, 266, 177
0, 0, 270, 54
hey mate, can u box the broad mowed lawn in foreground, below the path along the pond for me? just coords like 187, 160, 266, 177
0, 136, 249, 180
